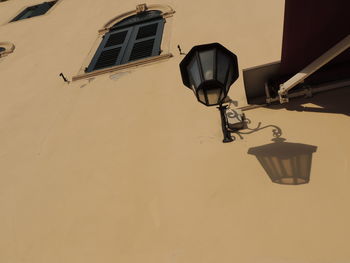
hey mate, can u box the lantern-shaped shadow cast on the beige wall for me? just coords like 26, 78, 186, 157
248, 138, 317, 185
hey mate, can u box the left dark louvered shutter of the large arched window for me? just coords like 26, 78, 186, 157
86, 27, 132, 72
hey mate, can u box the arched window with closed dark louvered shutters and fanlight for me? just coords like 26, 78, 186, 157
85, 10, 165, 72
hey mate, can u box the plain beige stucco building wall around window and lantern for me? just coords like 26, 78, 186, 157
0, 0, 350, 263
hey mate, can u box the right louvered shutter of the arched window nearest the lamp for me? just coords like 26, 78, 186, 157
121, 19, 164, 64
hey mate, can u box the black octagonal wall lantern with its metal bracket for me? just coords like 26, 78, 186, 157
180, 43, 244, 142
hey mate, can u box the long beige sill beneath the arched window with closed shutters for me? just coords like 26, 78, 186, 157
72, 53, 173, 81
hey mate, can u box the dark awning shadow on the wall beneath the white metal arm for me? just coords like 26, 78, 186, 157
269, 87, 350, 116
